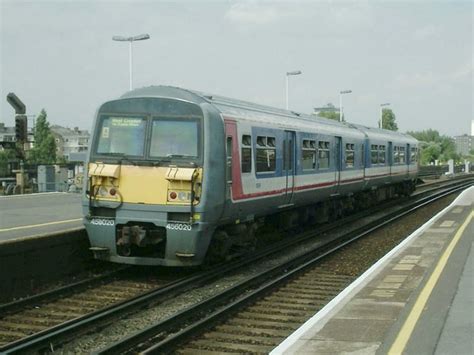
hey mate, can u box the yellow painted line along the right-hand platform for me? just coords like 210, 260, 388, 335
388, 211, 474, 355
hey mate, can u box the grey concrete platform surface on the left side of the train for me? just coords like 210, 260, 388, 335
0, 192, 82, 242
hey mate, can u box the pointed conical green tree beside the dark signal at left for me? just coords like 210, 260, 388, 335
29, 109, 56, 164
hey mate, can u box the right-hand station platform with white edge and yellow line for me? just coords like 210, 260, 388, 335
271, 187, 474, 355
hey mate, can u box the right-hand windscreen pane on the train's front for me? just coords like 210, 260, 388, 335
150, 118, 200, 158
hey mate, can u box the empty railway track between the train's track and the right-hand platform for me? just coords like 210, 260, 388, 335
94, 183, 471, 354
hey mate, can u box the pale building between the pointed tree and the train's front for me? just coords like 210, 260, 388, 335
51, 125, 90, 160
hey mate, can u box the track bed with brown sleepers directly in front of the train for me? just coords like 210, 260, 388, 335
0, 267, 180, 349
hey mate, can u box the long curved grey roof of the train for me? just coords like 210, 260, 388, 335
121, 85, 417, 142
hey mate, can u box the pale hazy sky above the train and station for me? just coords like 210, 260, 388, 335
0, 0, 474, 136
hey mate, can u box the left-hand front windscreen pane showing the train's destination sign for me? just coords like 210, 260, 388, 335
97, 116, 146, 156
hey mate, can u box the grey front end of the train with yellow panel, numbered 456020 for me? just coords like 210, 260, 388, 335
83, 94, 226, 266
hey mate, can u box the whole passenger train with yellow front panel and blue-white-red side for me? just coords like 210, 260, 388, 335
82, 86, 418, 267
